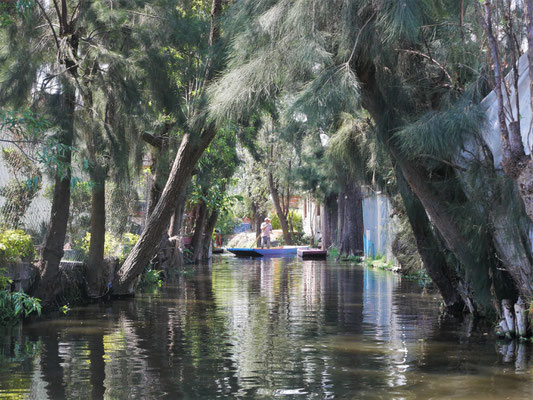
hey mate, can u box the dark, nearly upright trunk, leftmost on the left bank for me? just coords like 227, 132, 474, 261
33, 89, 76, 307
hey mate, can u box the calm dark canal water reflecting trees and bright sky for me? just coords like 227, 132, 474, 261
0, 256, 533, 400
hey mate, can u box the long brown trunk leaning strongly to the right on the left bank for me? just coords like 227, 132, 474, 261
113, 0, 222, 295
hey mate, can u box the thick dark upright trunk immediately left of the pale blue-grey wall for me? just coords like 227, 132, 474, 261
339, 182, 364, 256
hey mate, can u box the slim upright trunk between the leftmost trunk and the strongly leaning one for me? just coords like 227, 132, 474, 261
87, 174, 107, 298
